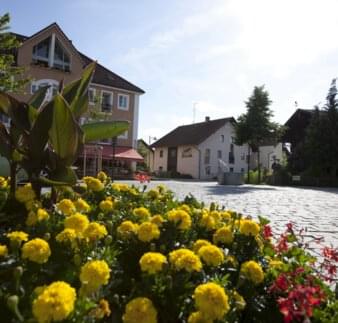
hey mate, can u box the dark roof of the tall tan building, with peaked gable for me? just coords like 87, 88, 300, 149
11, 22, 145, 94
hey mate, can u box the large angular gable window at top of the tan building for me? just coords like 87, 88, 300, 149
33, 34, 70, 72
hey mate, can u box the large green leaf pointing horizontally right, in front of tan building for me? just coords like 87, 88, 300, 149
81, 121, 129, 143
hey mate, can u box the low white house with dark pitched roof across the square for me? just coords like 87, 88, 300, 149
152, 117, 248, 180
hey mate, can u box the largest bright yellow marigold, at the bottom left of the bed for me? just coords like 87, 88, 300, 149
33, 281, 76, 323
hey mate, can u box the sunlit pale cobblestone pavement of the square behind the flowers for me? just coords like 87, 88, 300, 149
122, 181, 338, 247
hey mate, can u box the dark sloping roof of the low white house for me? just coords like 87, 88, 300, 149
152, 117, 236, 147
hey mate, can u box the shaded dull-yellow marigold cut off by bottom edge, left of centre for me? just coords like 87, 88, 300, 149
122, 297, 157, 323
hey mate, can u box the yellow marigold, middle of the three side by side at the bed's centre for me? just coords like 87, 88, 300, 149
169, 248, 202, 272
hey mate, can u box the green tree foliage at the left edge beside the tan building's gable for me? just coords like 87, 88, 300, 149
0, 13, 28, 92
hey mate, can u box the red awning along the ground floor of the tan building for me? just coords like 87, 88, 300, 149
82, 145, 143, 161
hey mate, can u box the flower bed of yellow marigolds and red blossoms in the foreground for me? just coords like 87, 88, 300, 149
0, 173, 338, 323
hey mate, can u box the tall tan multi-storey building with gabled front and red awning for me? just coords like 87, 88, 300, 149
3, 23, 145, 175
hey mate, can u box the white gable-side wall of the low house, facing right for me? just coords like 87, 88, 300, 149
198, 123, 247, 179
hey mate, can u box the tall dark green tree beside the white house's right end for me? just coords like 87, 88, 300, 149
235, 85, 280, 183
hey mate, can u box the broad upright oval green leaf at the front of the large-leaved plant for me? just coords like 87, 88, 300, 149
49, 94, 81, 165
